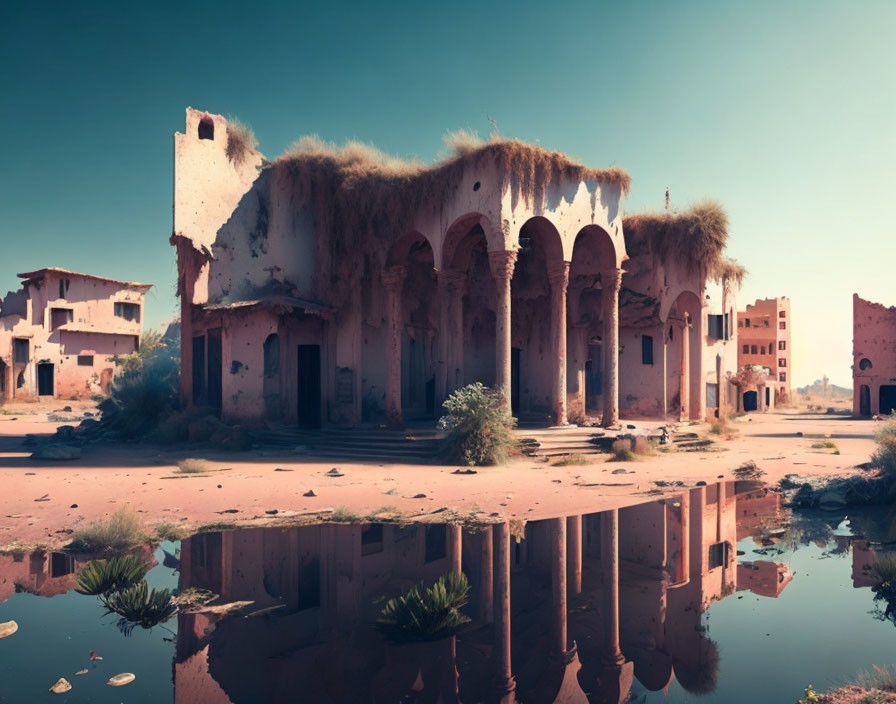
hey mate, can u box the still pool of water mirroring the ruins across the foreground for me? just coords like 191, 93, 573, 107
0, 482, 896, 704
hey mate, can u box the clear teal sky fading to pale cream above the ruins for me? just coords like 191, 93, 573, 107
0, 0, 896, 385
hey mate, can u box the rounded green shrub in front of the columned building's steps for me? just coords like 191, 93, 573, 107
439, 382, 517, 465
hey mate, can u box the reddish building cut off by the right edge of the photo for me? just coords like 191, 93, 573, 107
852, 294, 896, 418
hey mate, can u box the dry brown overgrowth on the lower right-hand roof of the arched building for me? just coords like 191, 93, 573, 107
622, 200, 747, 285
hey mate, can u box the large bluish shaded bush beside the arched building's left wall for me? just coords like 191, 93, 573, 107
103, 330, 180, 438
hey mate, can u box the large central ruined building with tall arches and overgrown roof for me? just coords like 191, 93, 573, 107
171, 109, 742, 427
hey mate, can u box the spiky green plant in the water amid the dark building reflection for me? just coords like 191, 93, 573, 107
376, 573, 470, 643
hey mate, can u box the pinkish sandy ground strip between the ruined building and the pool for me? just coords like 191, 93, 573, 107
0, 413, 876, 549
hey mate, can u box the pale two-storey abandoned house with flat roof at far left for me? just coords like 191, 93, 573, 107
0, 267, 151, 402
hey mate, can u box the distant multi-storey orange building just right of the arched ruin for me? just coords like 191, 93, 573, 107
737, 296, 791, 412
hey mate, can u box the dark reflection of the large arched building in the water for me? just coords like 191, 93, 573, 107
175, 482, 796, 704
